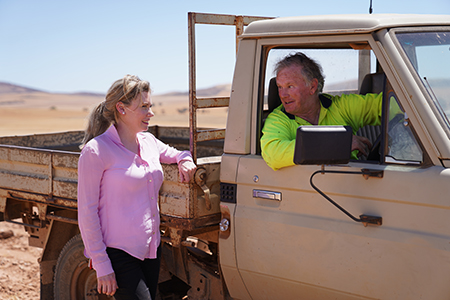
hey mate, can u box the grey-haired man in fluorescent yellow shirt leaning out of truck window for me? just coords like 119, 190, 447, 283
261, 52, 382, 170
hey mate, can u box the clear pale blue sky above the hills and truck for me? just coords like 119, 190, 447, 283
0, 0, 450, 94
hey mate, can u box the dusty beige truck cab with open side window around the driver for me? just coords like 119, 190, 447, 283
219, 15, 450, 299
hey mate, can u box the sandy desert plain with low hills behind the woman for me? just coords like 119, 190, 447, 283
0, 83, 230, 136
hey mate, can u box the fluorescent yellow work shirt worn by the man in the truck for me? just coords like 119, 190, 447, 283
261, 93, 383, 170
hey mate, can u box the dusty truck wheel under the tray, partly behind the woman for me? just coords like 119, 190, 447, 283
54, 234, 110, 300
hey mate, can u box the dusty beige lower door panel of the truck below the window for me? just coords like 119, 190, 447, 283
235, 147, 450, 299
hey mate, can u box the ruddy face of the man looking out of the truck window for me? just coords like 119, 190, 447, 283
277, 66, 317, 117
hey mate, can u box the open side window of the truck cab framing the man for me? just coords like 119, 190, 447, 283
259, 43, 424, 165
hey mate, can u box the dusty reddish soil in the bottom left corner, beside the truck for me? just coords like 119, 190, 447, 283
0, 222, 42, 300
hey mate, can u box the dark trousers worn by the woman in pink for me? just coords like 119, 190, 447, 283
106, 247, 161, 300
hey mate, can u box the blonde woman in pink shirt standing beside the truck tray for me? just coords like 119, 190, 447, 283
78, 75, 196, 300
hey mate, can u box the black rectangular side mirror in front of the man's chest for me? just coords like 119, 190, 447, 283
294, 125, 352, 165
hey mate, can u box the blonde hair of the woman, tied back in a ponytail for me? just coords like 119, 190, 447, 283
82, 75, 150, 145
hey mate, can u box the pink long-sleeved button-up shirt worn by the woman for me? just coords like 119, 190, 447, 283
78, 126, 192, 277
